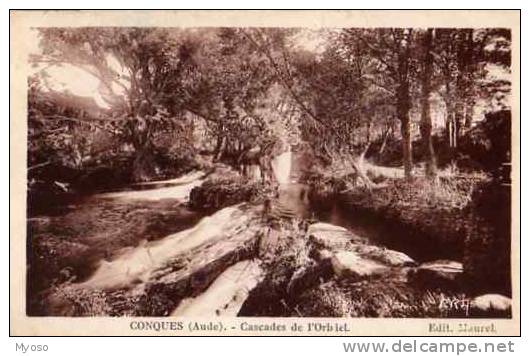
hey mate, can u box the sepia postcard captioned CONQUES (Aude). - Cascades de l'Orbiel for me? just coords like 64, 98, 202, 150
9, 10, 521, 336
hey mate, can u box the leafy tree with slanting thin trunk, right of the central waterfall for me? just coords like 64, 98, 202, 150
262, 29, 393, 187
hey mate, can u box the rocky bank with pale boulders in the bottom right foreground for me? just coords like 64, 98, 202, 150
238, 217, 510, 318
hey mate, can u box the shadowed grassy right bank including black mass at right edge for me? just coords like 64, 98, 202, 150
308, 168, 511, 295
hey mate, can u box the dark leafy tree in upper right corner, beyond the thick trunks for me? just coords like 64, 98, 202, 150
433, 28, 511, 150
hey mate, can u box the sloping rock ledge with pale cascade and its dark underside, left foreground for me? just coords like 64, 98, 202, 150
62, 206, 266, 316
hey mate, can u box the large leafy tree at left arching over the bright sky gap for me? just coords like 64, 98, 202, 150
31, 28, 204, 180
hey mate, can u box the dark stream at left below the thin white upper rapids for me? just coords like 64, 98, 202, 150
27, 172, 205, 315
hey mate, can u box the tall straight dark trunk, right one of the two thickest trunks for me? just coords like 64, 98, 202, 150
420, 28, 436, 178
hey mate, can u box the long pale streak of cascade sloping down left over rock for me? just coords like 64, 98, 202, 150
76, 206, 256, 290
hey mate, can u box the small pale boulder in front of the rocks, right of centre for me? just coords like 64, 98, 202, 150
331, 251, 388, 278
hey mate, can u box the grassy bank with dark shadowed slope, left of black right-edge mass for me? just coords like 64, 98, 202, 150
310, 177, 483, 260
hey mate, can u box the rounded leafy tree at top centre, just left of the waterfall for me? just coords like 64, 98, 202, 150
190, 28, 280, 172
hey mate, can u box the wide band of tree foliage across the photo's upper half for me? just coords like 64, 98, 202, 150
29, 27, 511, 189
